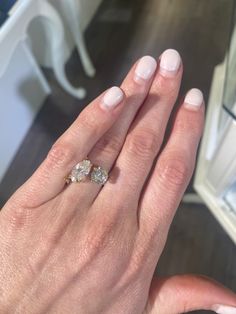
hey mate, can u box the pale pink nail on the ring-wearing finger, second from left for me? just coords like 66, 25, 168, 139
134, 56, 157, 83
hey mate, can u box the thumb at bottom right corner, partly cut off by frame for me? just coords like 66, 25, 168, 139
145, 275, 236, 314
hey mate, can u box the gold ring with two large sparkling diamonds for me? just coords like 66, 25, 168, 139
65, 159, 109, 185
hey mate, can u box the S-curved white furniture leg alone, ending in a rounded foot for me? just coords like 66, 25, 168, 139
40, 1, 86, 99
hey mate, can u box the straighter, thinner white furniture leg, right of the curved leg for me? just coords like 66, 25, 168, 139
61, 0, 96, 77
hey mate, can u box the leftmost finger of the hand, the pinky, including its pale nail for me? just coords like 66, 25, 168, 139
14, 87, 126, 207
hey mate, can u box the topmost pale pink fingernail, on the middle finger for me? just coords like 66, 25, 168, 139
160, 49, 181, 76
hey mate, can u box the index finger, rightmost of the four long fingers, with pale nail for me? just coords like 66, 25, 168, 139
139, 89, 204, 238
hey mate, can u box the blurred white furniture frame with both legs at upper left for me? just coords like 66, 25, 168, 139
0, 0, 95, 99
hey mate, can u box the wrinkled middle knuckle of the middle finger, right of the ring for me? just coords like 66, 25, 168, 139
127, 130, 161, 159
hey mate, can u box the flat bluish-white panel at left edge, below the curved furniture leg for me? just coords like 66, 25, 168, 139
0, 43, 50, 181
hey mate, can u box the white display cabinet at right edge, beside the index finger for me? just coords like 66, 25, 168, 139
194, 17, 236, 243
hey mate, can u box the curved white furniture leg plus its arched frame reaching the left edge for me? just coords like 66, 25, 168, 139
0, 0, 86, 99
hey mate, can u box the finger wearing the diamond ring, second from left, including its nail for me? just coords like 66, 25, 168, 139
62, 56, 157, 207
